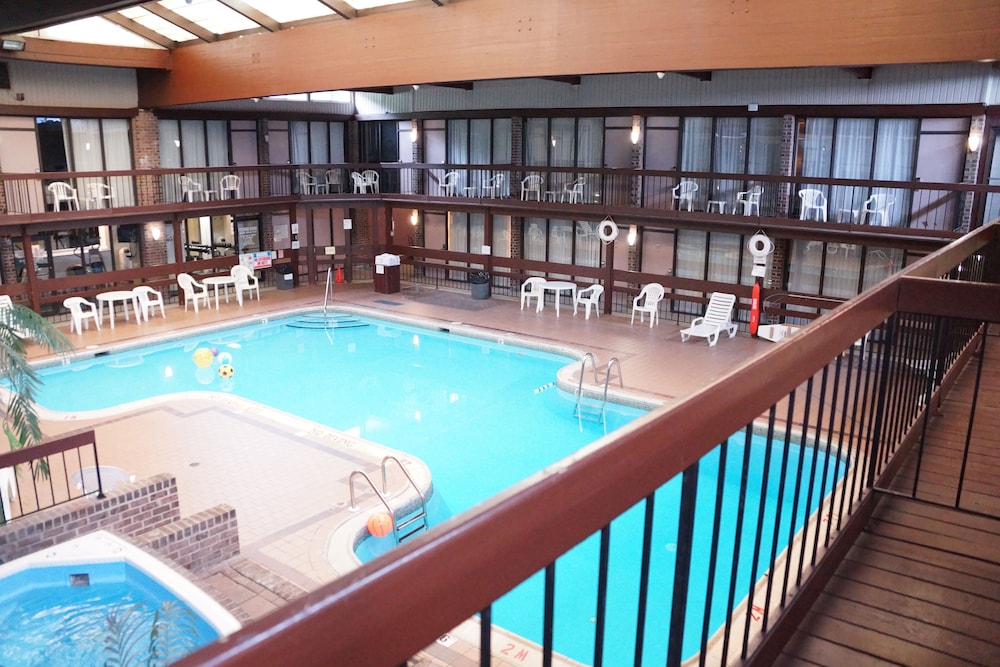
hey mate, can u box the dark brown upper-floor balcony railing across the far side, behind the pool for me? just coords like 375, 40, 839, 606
0, 163, 1000, 231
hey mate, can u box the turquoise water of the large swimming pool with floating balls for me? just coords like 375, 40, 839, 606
31, 318, 843, 665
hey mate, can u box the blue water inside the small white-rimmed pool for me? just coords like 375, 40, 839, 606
0, 562, 219, 667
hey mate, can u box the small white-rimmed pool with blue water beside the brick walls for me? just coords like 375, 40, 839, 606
0, 531, 239, 667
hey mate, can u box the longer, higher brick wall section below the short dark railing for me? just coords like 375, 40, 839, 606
0, 474, 180, 562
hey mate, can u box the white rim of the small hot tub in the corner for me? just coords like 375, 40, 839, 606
0, 530, 241, 637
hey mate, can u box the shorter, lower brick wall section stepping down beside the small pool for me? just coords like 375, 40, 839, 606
132, 505, 240, 572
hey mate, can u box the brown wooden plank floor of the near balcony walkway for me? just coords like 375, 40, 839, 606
777, 336, 1000, 667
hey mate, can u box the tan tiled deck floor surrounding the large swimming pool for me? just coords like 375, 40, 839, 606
23, 283, 774, 667
